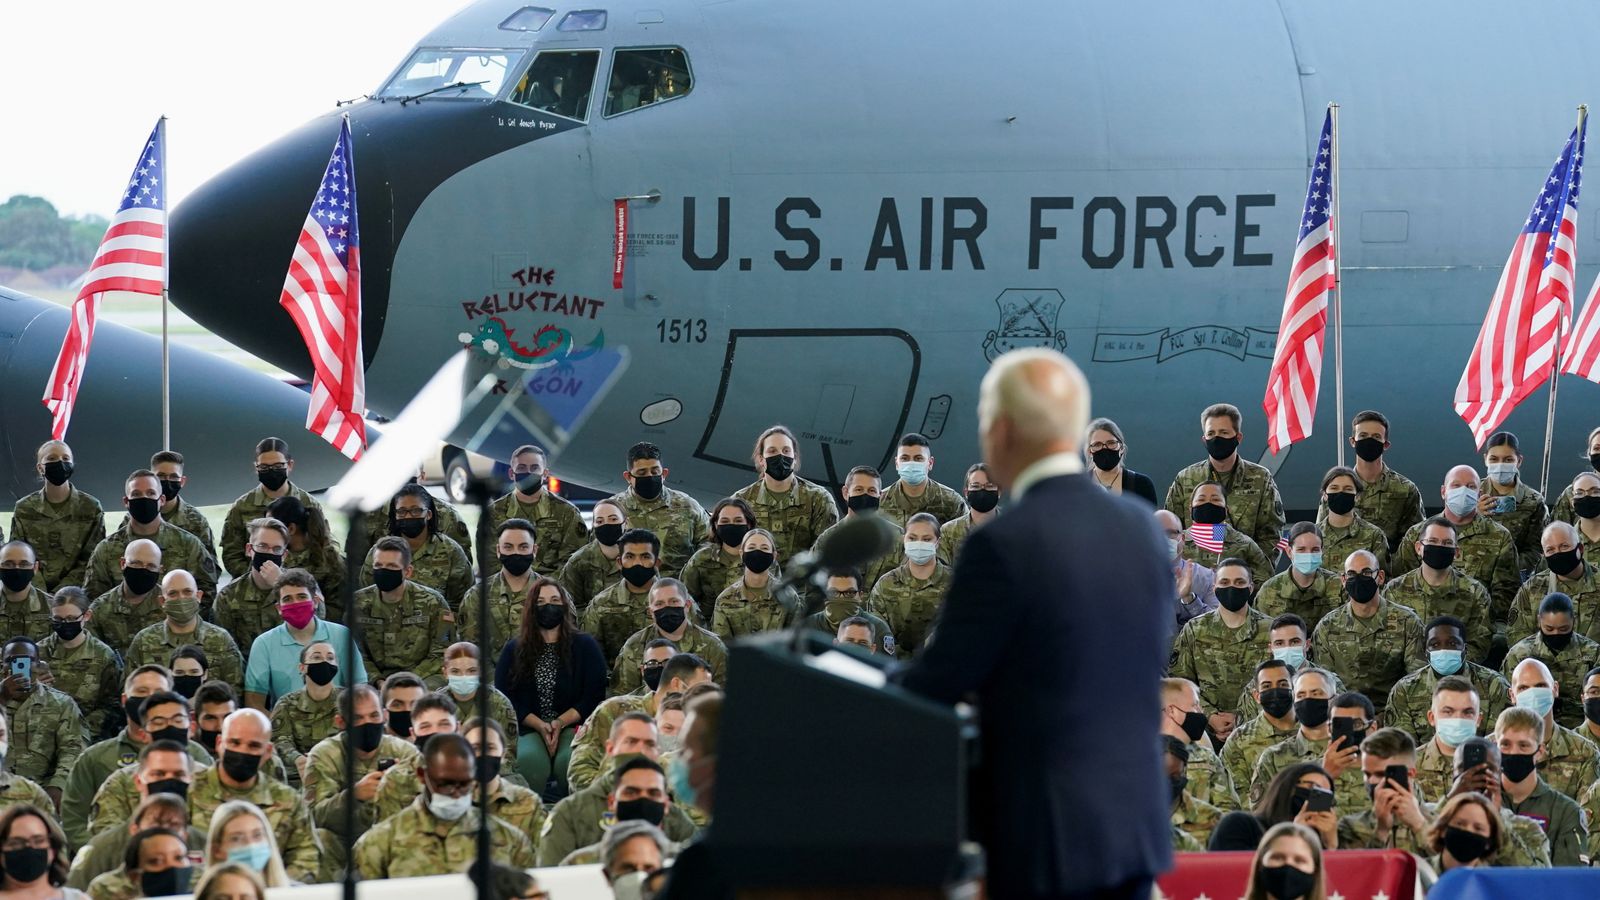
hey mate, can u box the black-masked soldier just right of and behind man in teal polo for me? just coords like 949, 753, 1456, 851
355, 536, 459, 684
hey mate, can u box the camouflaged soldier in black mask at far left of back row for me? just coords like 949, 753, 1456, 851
10, 440, 106, 596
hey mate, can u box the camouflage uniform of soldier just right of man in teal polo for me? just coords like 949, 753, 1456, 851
355, 576, 459, 684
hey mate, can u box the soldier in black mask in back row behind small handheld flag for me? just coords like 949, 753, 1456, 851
1165, 397, 1283, 554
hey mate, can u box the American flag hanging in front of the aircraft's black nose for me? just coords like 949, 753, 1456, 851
278, 119, 366, 460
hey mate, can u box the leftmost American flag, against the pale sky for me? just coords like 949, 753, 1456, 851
43, 119, 166, 440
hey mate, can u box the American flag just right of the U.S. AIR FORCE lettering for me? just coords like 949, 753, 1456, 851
1261, 109, 1336, 453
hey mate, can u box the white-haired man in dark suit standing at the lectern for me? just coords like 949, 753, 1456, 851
902, 349, 1173, 900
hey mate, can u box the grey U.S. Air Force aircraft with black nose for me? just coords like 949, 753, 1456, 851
15, 0, 1600, 508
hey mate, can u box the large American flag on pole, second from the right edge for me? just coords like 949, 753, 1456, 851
1456, 123, 1587, 447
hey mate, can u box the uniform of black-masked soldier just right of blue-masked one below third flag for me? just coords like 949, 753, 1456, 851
1312, 594, 1427, 713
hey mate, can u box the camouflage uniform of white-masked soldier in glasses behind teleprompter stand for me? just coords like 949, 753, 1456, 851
350, 798, 534, 879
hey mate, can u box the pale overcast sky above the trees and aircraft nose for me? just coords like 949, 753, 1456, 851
0, 0, 466, 218
